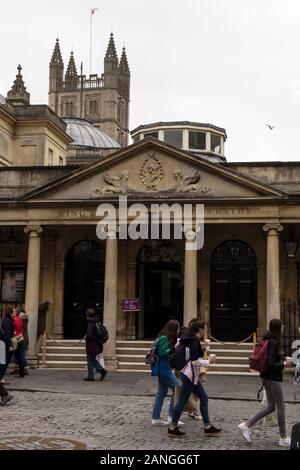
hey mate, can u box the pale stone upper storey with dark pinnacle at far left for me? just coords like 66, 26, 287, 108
0, 66, 72, 167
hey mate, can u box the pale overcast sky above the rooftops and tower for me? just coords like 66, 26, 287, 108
0, 0, 300, 161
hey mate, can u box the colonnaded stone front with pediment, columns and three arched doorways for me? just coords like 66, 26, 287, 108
0, 137, 300, 368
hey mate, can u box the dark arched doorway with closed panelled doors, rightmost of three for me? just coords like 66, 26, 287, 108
211, 240, 257, 341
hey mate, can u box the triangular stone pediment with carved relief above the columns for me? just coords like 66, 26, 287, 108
24, 139, 284, 201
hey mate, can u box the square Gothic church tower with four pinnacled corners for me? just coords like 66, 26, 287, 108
49, 34, 130, 147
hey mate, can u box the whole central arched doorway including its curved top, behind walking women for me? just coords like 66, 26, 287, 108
137, 240, 183, 338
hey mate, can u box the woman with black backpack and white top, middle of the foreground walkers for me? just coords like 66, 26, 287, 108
168, 320, 222, 437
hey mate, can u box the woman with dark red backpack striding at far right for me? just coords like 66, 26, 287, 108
238, 318, 293, 447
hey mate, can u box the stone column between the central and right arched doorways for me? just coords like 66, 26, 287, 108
183, 229, 197, 326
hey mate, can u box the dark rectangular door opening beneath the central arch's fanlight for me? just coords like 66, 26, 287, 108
144, 264, 182, 338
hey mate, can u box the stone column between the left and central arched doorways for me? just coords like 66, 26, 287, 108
103, 231, 118, 370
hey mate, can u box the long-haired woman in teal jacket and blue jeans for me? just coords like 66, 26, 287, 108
151, 320, 183, 426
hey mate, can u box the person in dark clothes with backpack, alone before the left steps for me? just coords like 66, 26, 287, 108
84, 308, 108, 382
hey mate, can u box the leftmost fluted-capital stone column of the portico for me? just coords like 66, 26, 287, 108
24, 225, 43, 360
